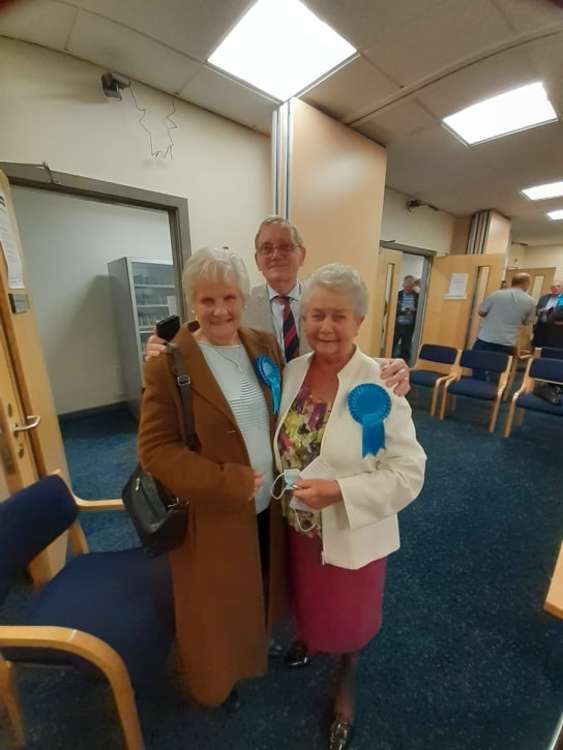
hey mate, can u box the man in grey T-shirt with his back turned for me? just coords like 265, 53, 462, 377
473, 273, 536, 380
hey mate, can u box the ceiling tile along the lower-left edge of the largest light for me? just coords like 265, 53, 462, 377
180, 66, 279, 133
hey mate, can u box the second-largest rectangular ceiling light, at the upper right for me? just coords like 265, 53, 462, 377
442, 82, 557, 145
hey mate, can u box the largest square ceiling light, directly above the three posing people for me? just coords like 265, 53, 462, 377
209, 0, 356, 101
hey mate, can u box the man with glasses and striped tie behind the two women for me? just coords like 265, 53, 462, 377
145, 216, 410, 396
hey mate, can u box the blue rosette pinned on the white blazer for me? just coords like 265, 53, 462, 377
348, 383, 391, 458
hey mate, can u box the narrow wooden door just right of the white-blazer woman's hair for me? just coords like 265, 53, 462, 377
370, 247, 401, 357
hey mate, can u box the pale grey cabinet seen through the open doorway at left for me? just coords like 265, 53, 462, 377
108, 258, 179, 415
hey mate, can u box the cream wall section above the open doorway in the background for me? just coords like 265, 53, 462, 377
381, 188, 455, 253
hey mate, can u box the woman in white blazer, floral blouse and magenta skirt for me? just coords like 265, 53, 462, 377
274, 263, 426, 750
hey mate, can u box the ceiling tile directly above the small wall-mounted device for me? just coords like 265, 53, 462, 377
69, 11, 201, 93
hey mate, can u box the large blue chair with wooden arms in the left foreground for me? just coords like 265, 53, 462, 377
0, 476, 174, 750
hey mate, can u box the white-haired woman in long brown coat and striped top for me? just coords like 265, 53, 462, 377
139, 250, 286, 706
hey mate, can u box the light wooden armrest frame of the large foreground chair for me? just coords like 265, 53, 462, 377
0, 478, 144, 750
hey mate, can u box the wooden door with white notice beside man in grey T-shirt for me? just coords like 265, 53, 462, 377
421, 253, 506, 349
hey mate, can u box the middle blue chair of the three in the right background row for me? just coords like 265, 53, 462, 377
440, 349, 512, 432
